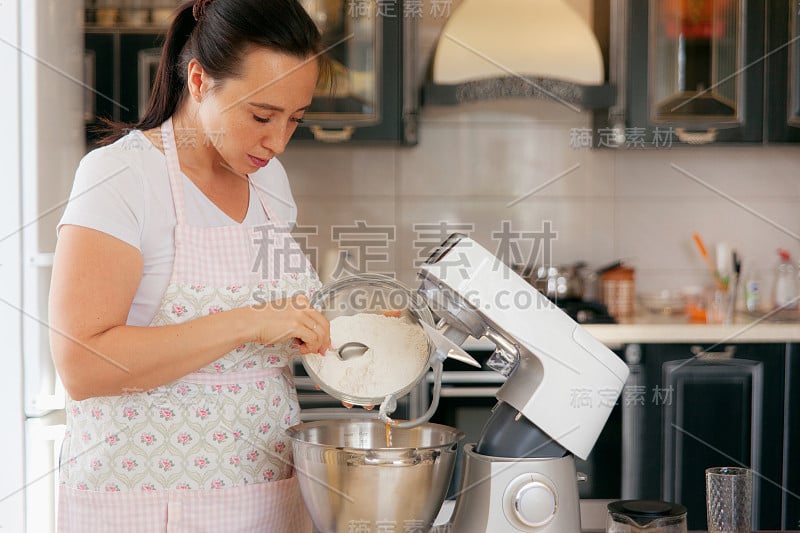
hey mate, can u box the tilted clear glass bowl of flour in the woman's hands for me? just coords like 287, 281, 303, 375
302, 274, 435, 406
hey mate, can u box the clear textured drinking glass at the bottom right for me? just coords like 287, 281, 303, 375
706, 466, 753, 533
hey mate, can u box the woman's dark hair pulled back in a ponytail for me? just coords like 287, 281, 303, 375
103, 0, 324, 143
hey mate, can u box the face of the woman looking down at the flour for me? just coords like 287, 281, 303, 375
191, 47, 319, 175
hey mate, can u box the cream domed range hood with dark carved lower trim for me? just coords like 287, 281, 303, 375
423, 0, 614, 110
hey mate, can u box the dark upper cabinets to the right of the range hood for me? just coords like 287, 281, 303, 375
598, 0, 800, 146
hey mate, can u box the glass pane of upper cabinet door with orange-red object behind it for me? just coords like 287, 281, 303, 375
648, 0, 745, 128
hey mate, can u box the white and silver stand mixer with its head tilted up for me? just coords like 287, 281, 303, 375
412, 234, 628, 533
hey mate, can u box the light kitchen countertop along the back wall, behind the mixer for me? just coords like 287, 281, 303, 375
463, 313, 800, 350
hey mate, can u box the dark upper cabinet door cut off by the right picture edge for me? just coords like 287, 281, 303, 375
765, 0, 800, 142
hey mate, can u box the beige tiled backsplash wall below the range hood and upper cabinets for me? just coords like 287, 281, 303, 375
281, 101, 800, 308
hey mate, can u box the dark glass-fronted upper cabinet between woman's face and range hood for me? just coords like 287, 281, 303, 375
294, 0, 421, 145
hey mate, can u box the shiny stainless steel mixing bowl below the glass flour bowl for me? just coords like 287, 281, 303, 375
287, 420, 464, 533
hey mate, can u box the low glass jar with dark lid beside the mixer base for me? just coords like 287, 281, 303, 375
606, 500, 686, 533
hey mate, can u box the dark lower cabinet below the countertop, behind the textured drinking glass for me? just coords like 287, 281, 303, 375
622, 344, 800, 530
